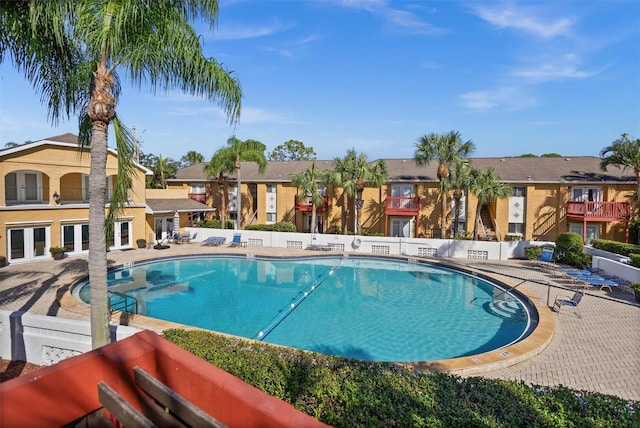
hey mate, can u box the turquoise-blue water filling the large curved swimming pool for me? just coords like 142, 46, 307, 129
74, 256, 530, 362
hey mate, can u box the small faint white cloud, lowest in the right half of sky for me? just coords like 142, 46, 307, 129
460, 86, 537, 111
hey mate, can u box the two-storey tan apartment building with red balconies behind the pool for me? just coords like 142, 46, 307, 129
167, 156, 636, 241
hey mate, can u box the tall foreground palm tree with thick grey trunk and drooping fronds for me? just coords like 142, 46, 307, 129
0, 0, 242, 348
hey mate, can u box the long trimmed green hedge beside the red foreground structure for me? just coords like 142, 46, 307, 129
163, 330, 640, 427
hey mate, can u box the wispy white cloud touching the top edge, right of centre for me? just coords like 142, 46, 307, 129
472, 4, 575, 39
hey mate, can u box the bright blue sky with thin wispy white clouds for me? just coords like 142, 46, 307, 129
0, 0, 640, 160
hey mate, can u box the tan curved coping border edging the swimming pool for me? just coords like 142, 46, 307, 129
58, 252, 555, 376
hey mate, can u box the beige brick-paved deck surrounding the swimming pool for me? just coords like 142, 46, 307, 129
0, 243, 640, 401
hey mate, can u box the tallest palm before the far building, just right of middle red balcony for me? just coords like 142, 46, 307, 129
413, 131, 475, 239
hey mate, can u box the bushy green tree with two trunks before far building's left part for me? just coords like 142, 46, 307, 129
204, 136, 267, 229
